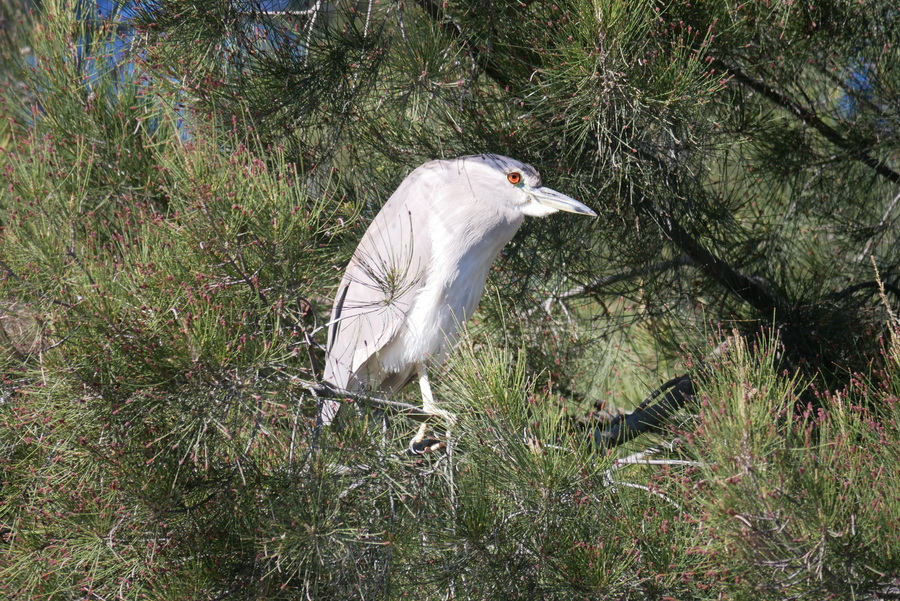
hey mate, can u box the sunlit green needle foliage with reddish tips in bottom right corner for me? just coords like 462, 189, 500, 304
683, 338, 900, 599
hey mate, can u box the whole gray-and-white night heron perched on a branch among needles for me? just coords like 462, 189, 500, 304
319, 154, 596, 435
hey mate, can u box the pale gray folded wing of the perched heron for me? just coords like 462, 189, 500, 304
325, 173, 431, 390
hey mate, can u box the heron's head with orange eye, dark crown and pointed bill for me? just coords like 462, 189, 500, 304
460, 154, 597, 217
